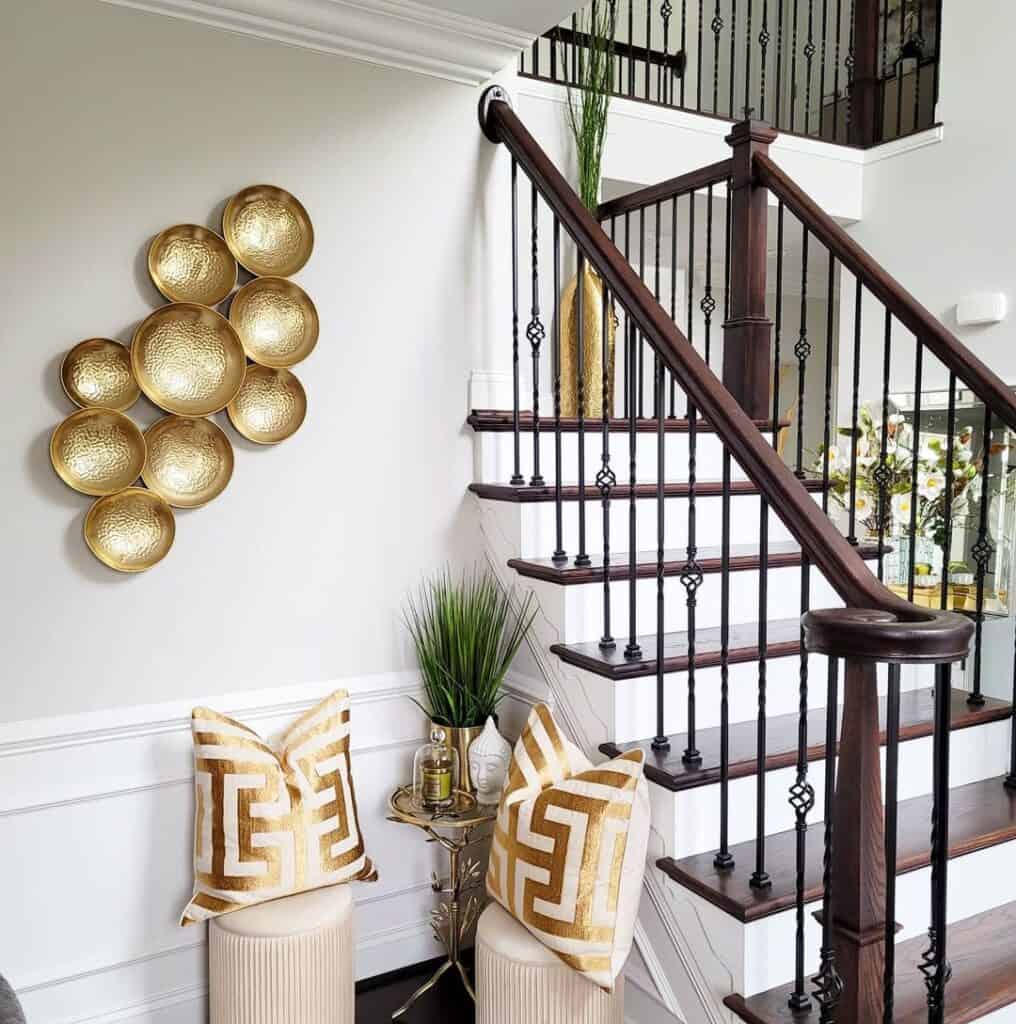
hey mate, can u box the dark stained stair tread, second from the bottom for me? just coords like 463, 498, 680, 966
657, 777, 1016, 923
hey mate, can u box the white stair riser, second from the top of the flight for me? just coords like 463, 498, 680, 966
516, 493, 818, 558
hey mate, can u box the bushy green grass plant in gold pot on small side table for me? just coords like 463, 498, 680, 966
405, 569, 536, 793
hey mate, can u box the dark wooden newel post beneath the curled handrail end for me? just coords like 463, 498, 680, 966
827, 658, 886, 1024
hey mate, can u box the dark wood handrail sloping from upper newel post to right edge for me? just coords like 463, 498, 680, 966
755, 156, 1016, 430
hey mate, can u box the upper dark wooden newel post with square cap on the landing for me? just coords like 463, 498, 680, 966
723, 120, 776, 420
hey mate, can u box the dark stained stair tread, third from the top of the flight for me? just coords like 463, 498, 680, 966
508, 541, 889, 587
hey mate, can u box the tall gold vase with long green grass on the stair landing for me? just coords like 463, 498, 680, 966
560, 0, 617, 417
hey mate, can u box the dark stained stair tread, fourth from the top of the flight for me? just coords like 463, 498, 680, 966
550, 618, 801, 680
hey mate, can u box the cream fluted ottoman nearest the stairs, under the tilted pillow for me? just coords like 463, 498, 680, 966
476, 903, 625, 1024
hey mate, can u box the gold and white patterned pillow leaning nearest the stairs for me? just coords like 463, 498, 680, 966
486, 705, 649, 991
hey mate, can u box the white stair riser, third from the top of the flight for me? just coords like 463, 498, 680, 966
553, 566, 843, 643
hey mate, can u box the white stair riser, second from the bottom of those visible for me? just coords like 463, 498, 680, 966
669, 722, 1011, 859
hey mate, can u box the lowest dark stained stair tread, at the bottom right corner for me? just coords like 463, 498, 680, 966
723, 903, 1016, 1024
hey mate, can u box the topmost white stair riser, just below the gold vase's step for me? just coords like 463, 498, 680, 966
473, 431, 746, 483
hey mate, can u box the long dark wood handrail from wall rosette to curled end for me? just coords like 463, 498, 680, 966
480, 94, 973, 663
